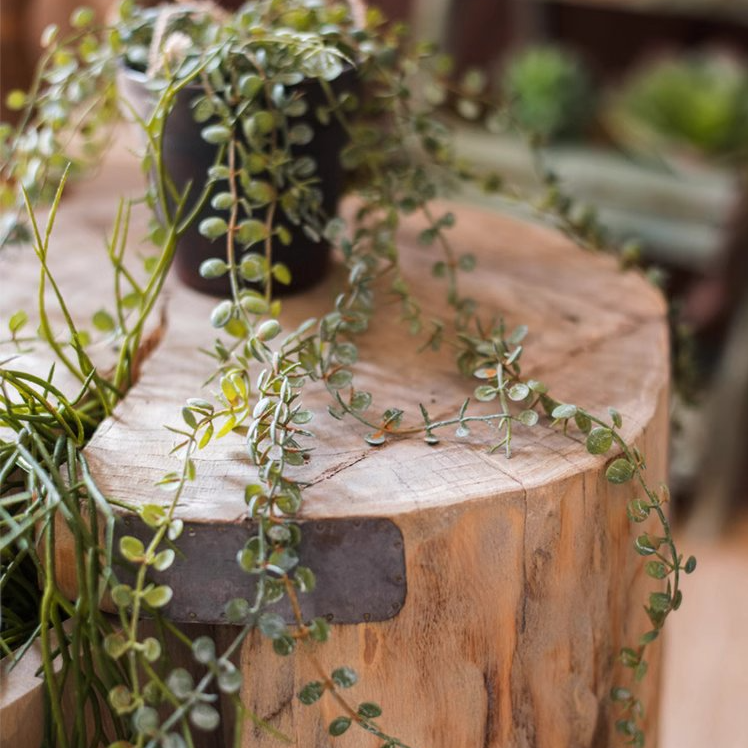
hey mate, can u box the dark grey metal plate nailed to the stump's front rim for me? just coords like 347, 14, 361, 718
115, 517, 407, 624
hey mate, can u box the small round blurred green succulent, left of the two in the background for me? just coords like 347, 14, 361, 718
502, 46, 594, 140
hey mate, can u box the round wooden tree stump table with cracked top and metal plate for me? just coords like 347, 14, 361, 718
0, 137, 669, 748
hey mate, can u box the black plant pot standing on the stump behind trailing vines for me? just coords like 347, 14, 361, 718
120, 69, 355, 296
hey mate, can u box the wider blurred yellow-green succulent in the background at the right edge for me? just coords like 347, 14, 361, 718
606, 53, 748, 162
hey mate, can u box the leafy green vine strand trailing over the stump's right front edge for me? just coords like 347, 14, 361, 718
314, 326, 696, 746
